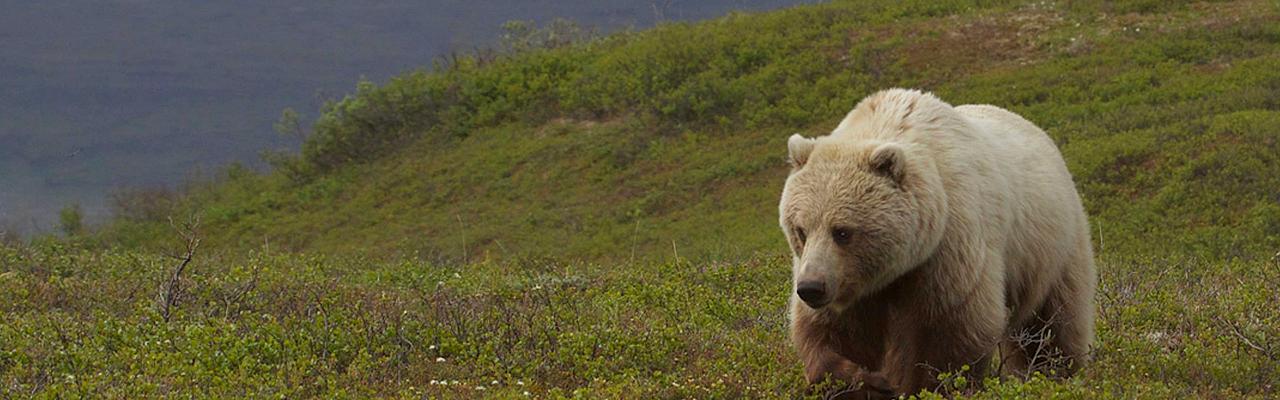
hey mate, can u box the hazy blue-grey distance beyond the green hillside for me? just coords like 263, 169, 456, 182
0, 0, 815, 233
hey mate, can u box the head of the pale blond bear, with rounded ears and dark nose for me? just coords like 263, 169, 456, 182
778, 135, 945, 313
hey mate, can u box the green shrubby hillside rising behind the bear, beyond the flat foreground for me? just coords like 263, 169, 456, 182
107, 3, 1280, 260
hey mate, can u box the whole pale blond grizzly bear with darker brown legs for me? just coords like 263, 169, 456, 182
778, 88, 1097, 394
